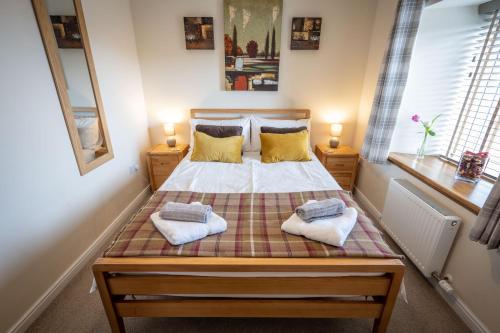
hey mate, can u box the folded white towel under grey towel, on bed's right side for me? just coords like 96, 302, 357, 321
281, 200, 358, 246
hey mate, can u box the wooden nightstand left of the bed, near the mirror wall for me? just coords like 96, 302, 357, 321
146, 144, 189, 191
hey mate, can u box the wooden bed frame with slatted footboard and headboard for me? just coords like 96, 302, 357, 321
93, 109, 405, 332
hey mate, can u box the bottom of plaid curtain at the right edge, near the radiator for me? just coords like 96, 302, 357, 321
469, 179, 500, 250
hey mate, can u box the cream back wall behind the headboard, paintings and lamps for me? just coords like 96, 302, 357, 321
132, 0, 377, 148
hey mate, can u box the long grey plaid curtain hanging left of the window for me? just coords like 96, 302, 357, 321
361, 0, 424, 163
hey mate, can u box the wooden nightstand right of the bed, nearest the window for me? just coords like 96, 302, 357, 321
316, 144, 359, 191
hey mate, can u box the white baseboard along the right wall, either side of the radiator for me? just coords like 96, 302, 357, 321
354, 188, 490, 333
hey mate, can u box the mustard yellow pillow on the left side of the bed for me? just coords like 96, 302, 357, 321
191, 131, 243, 163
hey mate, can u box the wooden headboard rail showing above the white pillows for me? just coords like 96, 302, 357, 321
191, 109, 311, 120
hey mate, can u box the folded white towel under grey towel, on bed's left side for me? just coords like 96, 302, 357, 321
151, 201, 227, 245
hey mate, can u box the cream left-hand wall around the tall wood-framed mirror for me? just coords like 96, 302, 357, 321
0, 0, 149, 332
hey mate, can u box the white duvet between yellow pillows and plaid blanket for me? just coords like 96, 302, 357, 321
159, 152, 341, 193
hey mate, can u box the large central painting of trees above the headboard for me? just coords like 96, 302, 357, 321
224, 0, 283, 91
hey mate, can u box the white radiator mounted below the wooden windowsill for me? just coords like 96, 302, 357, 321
381, 179, 461, 277
